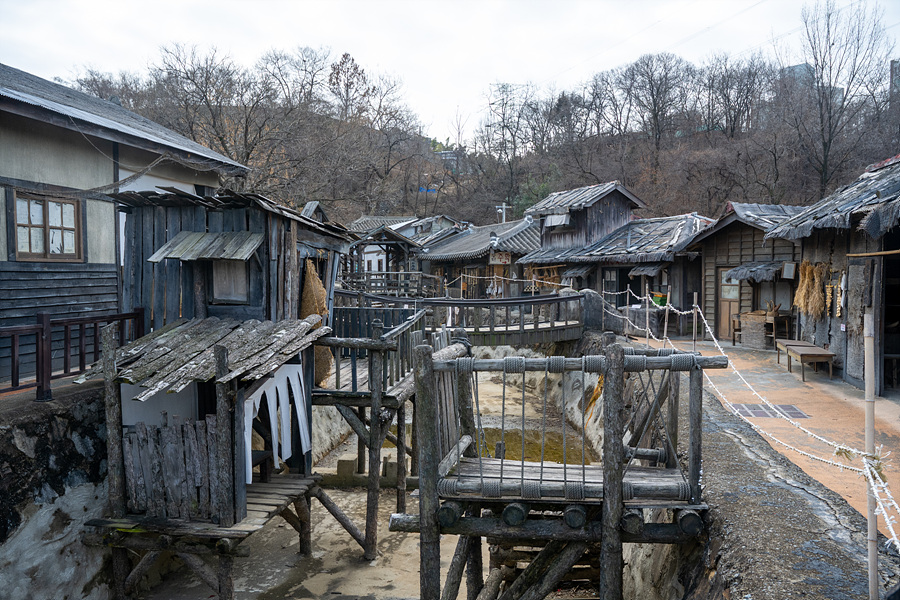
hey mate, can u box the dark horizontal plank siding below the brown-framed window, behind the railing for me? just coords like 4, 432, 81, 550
0, 261, 118, 377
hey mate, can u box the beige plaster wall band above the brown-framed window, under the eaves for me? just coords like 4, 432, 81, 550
0, 113, 113, 189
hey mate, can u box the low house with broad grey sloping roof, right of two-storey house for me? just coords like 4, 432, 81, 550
567, 213, 712, 307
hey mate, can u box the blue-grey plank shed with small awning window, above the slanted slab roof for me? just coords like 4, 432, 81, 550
113, 189, 351, 329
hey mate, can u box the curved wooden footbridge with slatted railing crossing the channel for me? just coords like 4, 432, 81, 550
332, 290, 584, 346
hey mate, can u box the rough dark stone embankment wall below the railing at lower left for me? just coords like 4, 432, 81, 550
0, 386, 108, 600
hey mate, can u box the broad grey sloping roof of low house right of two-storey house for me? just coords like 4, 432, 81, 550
567, 213, 713, 264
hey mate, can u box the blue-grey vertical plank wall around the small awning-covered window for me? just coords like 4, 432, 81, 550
122, 205, 276, 330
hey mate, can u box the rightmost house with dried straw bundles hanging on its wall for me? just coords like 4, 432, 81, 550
765, 156, 900, 393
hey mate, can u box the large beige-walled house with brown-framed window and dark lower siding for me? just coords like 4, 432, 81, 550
0, 65, 247, 399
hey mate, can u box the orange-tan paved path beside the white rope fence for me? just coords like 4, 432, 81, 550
657, 341, 900, 535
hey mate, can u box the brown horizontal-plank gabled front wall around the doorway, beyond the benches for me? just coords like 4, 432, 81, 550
700, 222, 800, 340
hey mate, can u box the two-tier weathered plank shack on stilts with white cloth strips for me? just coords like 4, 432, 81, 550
84, 190, 350, 598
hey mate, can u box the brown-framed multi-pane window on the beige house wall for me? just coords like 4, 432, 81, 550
16, 196, 81, 260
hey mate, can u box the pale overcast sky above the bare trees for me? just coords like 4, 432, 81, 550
0, 0, 900, 141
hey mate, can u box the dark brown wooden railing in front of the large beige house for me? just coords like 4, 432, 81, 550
0, 308, 144, 402
